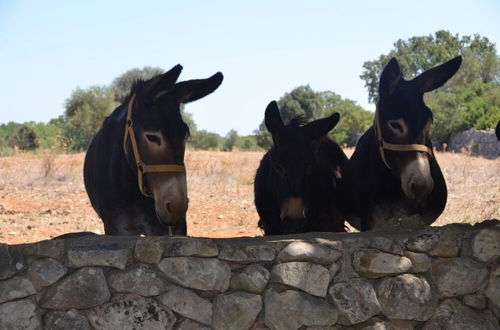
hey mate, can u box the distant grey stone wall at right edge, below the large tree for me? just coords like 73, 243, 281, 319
447, 128, 500, 159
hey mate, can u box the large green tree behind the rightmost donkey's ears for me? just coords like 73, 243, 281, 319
360, 30, 500, 148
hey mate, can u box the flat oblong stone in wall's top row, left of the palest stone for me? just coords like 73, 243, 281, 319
219, 245, 276, 264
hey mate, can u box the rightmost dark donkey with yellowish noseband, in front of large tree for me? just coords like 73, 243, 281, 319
341, 56, 462, 231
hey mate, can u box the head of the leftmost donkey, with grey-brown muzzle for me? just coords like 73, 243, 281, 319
125, 65, 223, 226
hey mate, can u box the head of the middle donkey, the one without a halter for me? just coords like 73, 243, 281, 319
265, 101, 339, 232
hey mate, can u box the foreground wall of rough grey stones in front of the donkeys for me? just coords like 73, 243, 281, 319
0, 220, 500, 330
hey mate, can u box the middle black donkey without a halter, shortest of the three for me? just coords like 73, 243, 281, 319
254, 101, 347, 235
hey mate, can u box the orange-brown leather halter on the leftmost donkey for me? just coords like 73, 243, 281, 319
123, 94, 186, 197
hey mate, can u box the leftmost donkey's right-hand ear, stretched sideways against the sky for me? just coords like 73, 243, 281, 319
172, 72, 224, 103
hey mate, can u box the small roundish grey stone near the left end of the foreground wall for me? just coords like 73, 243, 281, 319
28, 258, 68, 288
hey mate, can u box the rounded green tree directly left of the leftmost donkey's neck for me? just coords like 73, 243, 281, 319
62, 86, 116, 151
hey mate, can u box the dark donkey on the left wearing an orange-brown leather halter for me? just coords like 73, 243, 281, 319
83, 65, 223, 235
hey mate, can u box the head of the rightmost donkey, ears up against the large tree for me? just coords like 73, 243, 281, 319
375, 56, 462, 204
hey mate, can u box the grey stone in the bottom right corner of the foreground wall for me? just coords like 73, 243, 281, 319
423, 299, 499, 330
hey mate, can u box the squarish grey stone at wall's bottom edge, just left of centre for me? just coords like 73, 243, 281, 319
212, 291, 262, 330
